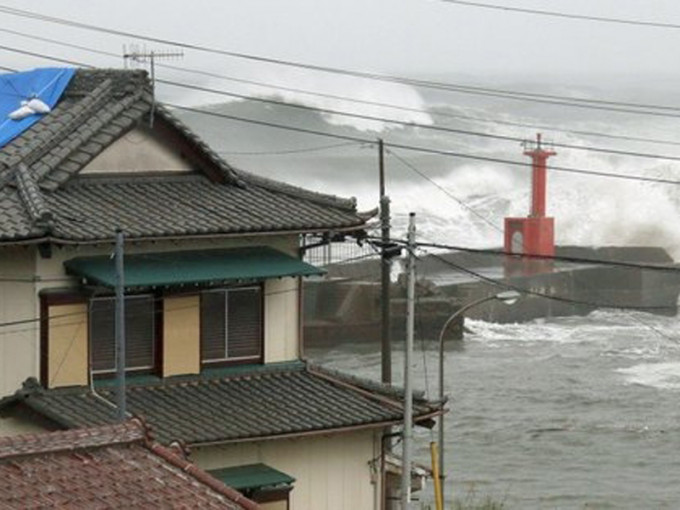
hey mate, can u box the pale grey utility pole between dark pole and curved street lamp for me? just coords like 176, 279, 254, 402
401, 213, 416, 510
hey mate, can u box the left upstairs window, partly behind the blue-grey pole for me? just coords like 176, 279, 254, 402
89, 296, 155, 373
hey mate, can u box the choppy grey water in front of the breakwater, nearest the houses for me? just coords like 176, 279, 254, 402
307, 312, 680, 509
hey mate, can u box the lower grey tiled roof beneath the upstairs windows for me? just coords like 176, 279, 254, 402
0, 362, 438, 444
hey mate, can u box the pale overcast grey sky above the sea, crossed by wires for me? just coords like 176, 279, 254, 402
0, 0, 680, 84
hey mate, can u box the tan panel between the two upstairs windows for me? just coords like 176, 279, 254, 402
163, 296, 201, 377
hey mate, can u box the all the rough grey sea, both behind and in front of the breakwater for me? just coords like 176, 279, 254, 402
178, 76, 680, 509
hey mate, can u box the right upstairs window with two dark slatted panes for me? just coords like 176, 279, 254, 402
201, 287, 262, 363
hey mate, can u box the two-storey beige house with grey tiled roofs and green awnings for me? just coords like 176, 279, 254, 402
0, 69, 441, 510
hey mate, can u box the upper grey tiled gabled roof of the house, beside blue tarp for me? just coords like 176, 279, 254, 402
0, 70, 366, 242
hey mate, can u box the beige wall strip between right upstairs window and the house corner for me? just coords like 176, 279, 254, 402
264, 278, 300, 363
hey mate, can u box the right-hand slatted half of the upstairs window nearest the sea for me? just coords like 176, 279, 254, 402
227, 287, 262, 358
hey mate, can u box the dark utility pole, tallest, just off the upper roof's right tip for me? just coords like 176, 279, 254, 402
378, 138, 392, 384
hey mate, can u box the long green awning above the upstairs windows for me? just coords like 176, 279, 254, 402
64, 246, 324, 288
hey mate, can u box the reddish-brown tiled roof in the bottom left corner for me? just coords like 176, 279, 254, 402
0, 419, 260, 510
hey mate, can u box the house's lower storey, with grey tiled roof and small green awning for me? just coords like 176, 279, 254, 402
0, 361, 440, 510
